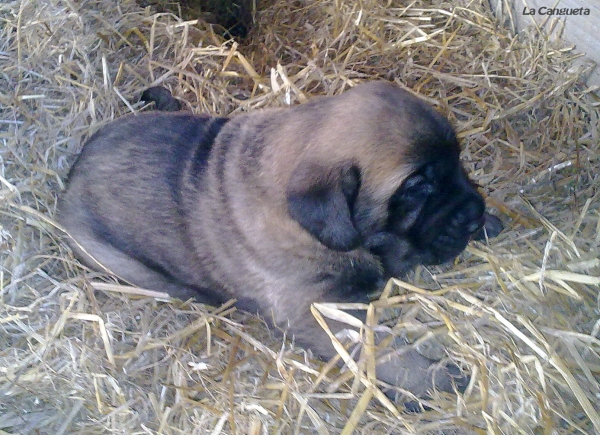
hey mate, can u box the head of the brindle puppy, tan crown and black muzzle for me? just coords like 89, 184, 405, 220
286, 82, 485, 270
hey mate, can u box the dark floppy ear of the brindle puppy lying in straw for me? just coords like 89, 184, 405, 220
286, 162, 360, 251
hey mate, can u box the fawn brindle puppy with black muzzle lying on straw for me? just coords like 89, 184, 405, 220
59, 82, 499, 402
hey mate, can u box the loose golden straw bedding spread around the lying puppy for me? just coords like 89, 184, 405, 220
0, 0, 600, 435
